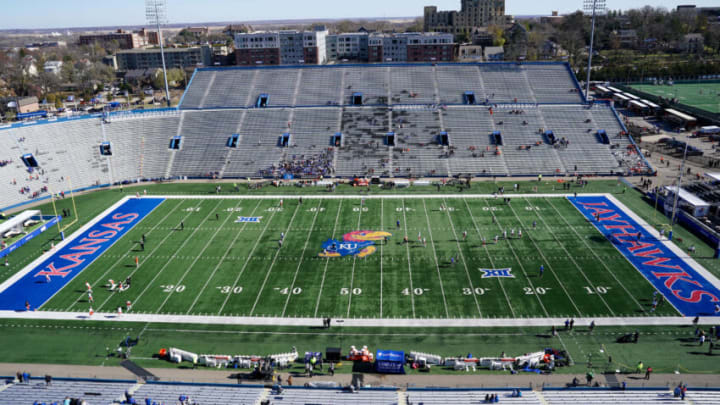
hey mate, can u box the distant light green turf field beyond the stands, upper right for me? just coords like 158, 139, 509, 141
630, 82, 720, 114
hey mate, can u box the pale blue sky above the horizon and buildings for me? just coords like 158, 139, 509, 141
0, 0, 717, 29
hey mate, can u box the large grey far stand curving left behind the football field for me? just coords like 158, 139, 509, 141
0, 63, 651, 208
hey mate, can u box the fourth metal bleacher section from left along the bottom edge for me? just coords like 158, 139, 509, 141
407, 389, 542, 405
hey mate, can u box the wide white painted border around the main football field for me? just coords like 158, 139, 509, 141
0, 193, 720, 327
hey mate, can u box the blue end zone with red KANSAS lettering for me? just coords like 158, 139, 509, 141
0, 198, 165, 310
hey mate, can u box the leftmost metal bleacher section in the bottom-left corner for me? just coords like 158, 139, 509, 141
0, 378, 135, 405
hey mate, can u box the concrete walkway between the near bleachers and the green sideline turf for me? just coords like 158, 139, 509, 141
0, 363, 720, 389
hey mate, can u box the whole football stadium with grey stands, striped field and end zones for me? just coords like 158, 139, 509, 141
0, 62, 720, 404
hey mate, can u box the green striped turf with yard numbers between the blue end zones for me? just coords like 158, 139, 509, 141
41, 196, 678, 318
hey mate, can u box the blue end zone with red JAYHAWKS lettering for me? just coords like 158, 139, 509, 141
568, 197, 720, 316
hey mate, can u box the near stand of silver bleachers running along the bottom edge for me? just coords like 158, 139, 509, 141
0, 377, 720, 405
